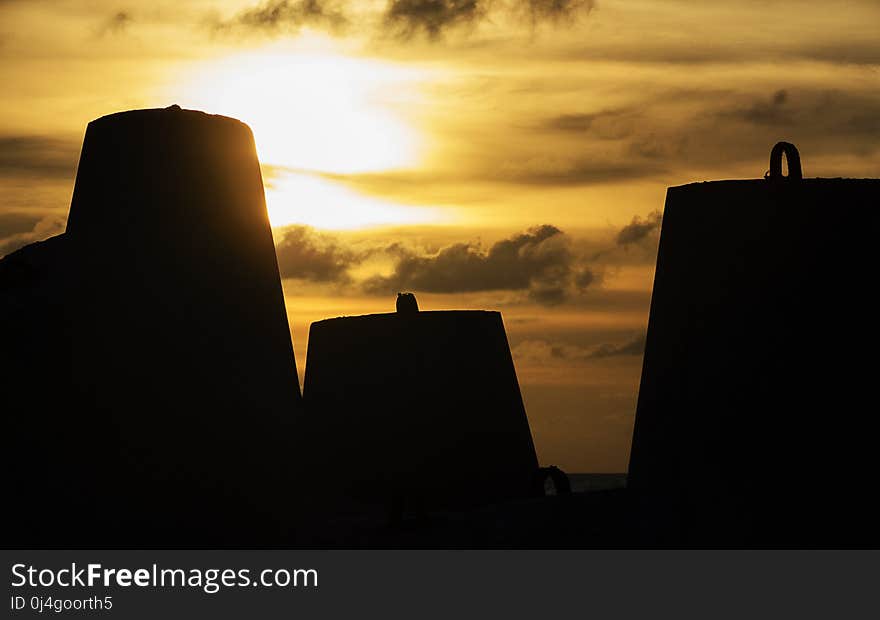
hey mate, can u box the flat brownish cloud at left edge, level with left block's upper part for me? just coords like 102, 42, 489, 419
0, 136, 79, 178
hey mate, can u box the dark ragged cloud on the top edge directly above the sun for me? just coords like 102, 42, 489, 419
214, 0, 348, 33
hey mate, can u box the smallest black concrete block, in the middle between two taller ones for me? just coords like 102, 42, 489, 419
303, 311, 538, 505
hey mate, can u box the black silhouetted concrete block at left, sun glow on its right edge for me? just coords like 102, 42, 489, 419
0, 108, 300, 546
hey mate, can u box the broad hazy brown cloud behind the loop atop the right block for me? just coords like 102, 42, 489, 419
524, 83, 880, 187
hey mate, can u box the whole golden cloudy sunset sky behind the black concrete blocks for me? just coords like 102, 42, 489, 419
0, 0, 880, 471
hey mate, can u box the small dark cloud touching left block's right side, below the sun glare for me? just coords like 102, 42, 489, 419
275, 226, 362, 283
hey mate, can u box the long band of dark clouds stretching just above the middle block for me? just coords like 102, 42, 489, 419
276, 214, 659, 307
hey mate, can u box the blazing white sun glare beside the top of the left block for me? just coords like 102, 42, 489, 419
175, 38, 438, 229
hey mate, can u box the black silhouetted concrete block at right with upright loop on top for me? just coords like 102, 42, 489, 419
628, 145, 880, 546
